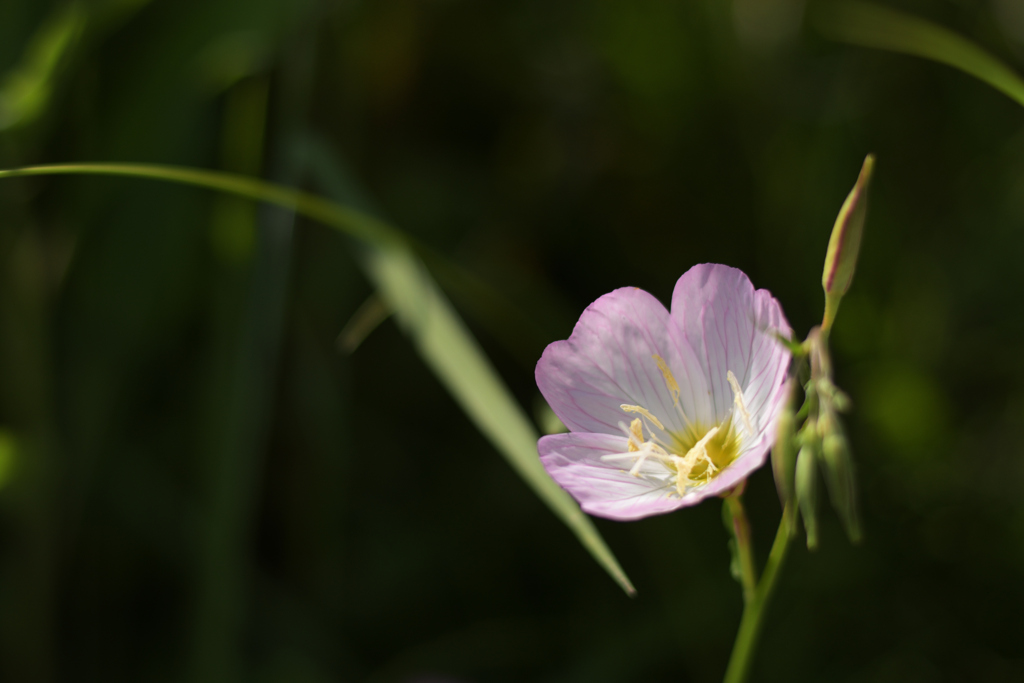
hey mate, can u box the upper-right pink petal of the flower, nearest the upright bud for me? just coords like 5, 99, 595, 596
672, 263, 791, 428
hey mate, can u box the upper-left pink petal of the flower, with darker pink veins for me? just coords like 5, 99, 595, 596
537, 287, 692, 434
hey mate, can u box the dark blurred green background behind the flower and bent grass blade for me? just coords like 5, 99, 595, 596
0, 0, 1024, 683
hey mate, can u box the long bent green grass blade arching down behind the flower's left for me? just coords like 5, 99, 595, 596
0, 164, 635, 594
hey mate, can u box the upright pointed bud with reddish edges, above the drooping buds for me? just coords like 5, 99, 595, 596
821, 155, 874, 330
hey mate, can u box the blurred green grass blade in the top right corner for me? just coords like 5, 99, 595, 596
811, 0, 1024, 105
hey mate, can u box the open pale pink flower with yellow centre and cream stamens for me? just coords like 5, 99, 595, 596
537, 263, 792, 520
